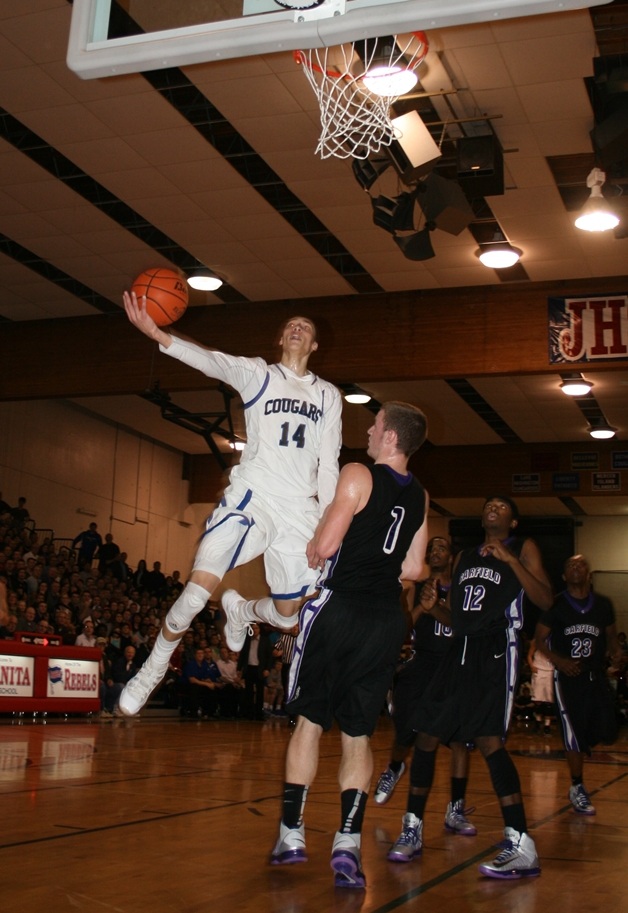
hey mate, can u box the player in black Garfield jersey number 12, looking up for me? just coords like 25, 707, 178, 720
390, 496, 552, 878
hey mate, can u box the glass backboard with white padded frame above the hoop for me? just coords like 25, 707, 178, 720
67, 0, 609, 79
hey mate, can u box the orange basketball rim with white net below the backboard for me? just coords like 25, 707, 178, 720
294, 32, 428, 159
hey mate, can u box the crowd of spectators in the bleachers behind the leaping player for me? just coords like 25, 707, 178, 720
0, 493, 286, 719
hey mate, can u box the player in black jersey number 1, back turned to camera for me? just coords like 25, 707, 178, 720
271, 403, 428, 888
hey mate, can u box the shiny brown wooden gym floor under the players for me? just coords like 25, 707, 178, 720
0, 715, 628, 913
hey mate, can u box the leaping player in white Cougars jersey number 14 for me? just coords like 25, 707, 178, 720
120, 292, 342, 716
